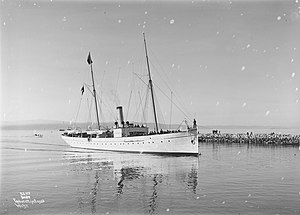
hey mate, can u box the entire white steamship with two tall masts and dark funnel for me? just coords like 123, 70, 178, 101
62, 33, 199, 155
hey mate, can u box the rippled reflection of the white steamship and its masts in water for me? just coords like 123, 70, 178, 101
64, 150, 199, 214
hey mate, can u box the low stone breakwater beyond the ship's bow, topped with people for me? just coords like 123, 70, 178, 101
198, 133, 300, 145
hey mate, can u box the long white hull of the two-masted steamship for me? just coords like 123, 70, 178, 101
62, 129, 198, 154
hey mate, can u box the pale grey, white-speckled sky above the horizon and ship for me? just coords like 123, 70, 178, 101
0, 0, 300, 126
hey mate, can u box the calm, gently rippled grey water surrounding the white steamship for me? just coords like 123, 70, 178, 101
0, 131, 300, 214
